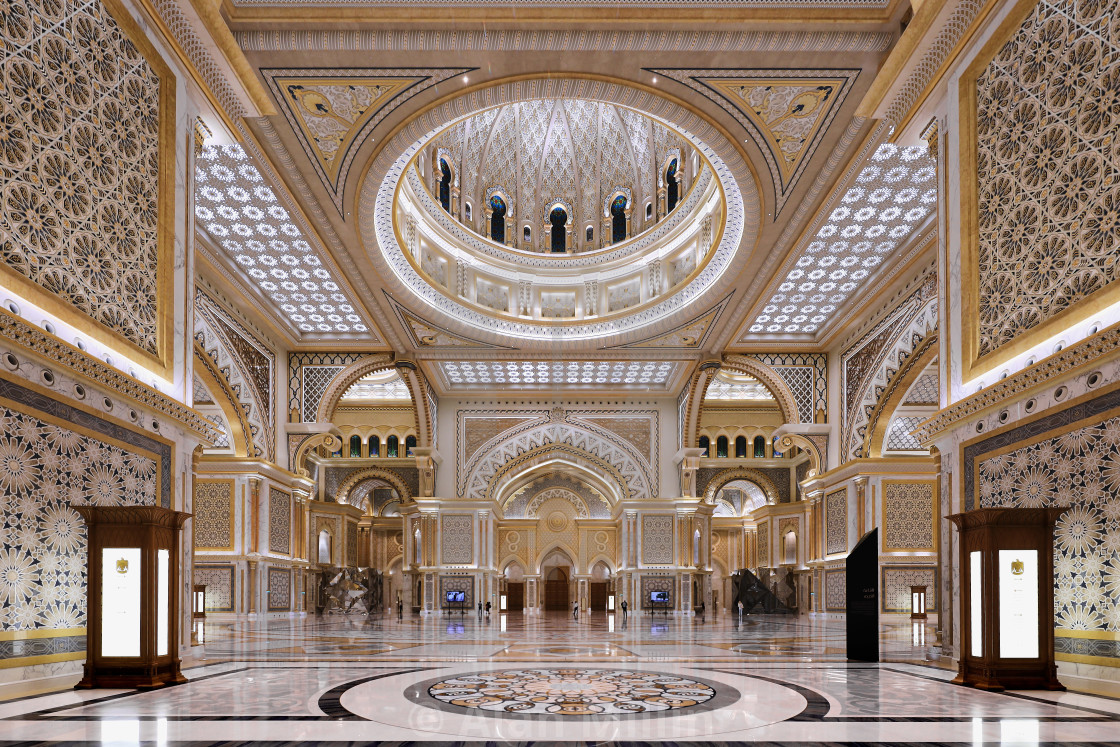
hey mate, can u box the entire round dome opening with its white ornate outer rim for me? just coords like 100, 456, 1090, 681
358, 80, 759, 346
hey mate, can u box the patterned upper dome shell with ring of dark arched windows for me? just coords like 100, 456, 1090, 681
417, 100, 703, 253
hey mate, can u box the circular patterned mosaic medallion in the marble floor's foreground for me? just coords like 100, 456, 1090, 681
405, 667, 739, 718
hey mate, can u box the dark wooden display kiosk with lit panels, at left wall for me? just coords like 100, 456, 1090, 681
75, 506, 190, 688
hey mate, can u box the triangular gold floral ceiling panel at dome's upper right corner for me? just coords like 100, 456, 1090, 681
647, 68, 859, 221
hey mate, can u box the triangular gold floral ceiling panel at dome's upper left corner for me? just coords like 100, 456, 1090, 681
261, 67, 477, 213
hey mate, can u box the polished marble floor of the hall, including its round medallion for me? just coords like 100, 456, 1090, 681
0, 613, 1120, 745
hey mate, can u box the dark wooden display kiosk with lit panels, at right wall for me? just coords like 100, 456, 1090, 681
948, 508, 1065, 690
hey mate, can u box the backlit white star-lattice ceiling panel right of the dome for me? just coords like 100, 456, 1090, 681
739, 143, 937, 342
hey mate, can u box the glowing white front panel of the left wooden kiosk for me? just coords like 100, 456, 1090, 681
101, 548, 141, 656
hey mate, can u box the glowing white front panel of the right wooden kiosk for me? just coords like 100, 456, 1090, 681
999, 550, 1038, 659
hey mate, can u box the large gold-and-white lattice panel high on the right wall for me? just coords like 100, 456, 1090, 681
962, 1, 1120, 358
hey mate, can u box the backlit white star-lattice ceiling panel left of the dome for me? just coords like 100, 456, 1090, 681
195, 144, 371, 337
